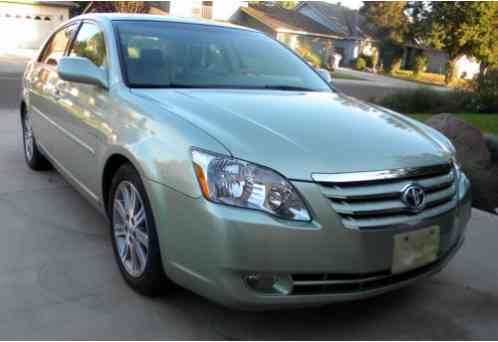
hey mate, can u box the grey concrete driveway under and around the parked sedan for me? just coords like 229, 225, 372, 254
0, 56, 498, 340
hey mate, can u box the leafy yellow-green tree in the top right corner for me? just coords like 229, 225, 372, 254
418, 1, 498, 84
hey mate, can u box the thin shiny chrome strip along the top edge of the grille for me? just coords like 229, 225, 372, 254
311, 162, 452, 183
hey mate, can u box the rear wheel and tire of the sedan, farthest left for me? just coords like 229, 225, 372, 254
21, 112, 52, 171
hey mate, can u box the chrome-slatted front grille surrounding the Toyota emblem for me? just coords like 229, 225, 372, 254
313, 164, 457, 229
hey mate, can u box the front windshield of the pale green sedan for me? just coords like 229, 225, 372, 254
114, 21, 331, 91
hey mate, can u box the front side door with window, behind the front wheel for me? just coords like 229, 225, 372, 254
49, 22, 108, 199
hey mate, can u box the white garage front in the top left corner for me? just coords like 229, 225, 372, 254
0, 0, 77, 50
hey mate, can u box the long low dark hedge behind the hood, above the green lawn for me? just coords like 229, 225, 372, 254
372, 89, 480, 114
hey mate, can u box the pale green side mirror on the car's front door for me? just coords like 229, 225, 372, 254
57, 57, 109, 89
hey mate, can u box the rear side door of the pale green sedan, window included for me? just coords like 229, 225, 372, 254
28, 23, 78, 159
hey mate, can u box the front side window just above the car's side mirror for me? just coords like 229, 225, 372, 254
69, 23, 107, 68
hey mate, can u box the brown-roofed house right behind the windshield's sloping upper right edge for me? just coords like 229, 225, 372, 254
230, 4, 342, 66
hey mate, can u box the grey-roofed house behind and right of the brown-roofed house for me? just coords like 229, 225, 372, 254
295, 1, 377, 65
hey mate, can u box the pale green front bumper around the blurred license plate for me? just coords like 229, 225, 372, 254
146, 176, 471, 309
